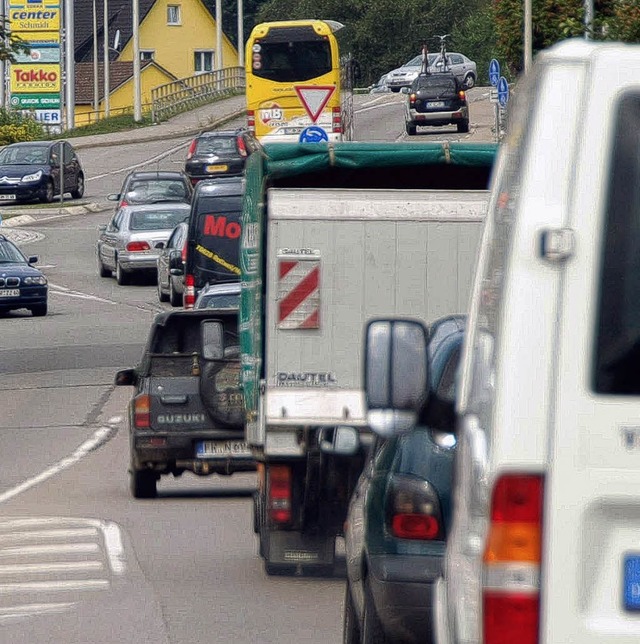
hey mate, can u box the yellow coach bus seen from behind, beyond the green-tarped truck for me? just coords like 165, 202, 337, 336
245, 20, 355, 143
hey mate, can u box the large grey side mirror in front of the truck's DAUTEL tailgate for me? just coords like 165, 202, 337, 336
364, 320, 430, 438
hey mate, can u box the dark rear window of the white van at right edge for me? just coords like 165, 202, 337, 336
593, 93, 640, 395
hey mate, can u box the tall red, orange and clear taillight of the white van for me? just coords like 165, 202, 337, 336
483, 474, 544, 644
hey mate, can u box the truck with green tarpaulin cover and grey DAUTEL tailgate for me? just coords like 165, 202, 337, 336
240, 142, 497, 574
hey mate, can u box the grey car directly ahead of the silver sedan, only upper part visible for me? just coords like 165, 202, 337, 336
107, 170, 193, 208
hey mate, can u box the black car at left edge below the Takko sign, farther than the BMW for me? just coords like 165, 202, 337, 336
0, 141, 84, 203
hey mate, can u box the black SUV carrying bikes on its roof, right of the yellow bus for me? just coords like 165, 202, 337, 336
405, 72, 469, 135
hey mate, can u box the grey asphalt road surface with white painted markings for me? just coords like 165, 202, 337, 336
0, 90, 491, 644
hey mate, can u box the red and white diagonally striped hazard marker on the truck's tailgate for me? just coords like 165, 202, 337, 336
278, 259, 320, 329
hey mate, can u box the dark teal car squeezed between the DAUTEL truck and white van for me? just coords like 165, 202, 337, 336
344, 316, 465, 644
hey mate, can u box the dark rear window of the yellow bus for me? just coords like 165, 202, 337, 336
253, 40, 331, 83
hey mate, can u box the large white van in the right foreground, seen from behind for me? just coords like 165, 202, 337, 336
434, 41, 640, 644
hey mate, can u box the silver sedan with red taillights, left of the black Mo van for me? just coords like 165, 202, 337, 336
96, 202, 191, 284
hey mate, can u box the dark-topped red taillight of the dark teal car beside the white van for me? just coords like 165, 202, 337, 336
386, 474, 444, 541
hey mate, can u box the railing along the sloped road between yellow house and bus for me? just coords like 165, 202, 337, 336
151, 67, 245, 123
